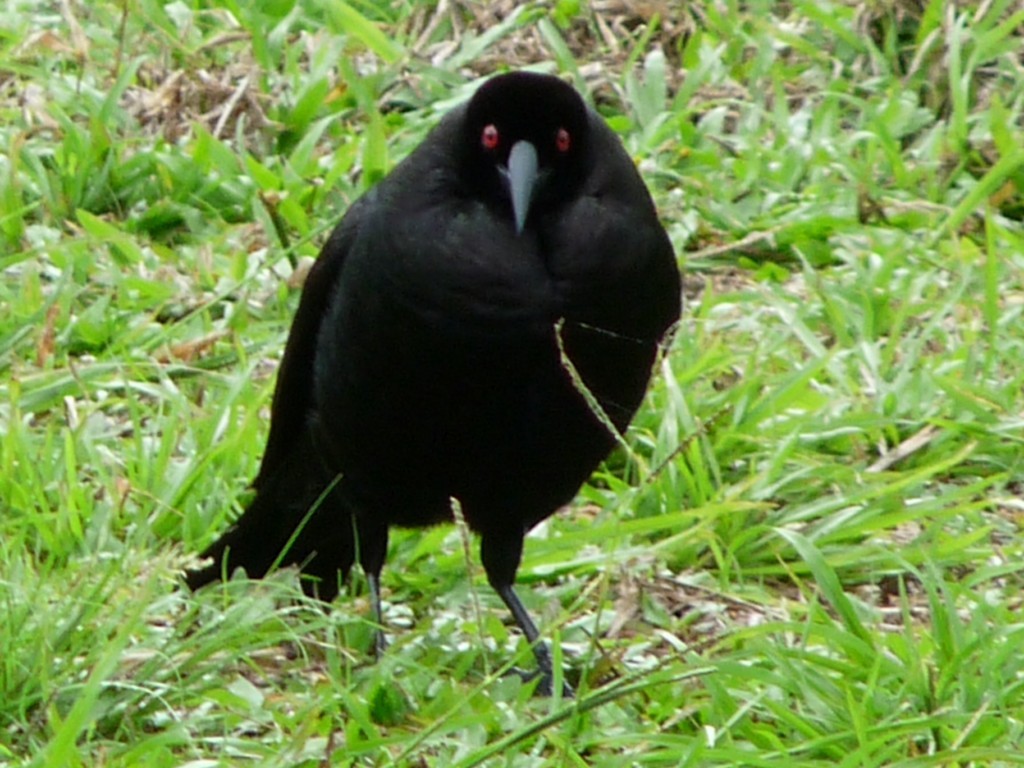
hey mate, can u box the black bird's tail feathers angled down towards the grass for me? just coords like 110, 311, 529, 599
185, 440, 355, 600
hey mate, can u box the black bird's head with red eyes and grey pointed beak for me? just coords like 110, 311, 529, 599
462, 72, 588, 232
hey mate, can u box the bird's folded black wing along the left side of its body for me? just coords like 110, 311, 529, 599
253, 193, 372, 488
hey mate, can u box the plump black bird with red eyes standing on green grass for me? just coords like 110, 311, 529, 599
187, 73, 680, 689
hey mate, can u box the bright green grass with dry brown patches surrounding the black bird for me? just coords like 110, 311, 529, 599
0, 0, 1024, 768
